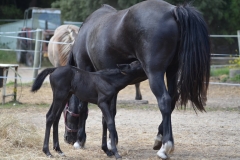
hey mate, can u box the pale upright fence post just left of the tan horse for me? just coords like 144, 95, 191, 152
33, 29, 42, 81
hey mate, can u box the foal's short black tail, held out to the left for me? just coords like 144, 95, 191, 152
31, 68, 56, 92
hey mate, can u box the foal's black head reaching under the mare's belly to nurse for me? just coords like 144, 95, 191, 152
117, 61, 147, 84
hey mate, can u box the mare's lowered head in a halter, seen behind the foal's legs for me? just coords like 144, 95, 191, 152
64, 96, 80, 144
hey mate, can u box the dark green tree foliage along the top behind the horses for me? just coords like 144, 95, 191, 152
0, 0, 240, 34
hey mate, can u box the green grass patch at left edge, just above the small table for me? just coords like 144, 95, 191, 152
0, 51, 17, 64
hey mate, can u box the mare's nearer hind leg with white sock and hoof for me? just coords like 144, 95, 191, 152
148, 71, 174, 159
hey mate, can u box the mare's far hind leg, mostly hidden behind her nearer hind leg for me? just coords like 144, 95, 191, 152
153, 63, 178, 151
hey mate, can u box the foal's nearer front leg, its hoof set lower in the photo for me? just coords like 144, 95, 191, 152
98, 102, 122, 159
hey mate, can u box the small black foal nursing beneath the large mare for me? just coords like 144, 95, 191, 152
31, 61, 145, 159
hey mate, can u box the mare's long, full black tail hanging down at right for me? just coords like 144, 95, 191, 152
174, 4, 210, 111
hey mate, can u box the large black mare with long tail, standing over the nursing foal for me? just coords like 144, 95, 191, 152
65, 0, 210, 158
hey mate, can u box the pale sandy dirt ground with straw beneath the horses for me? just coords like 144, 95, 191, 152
0, 68, 240, 160
